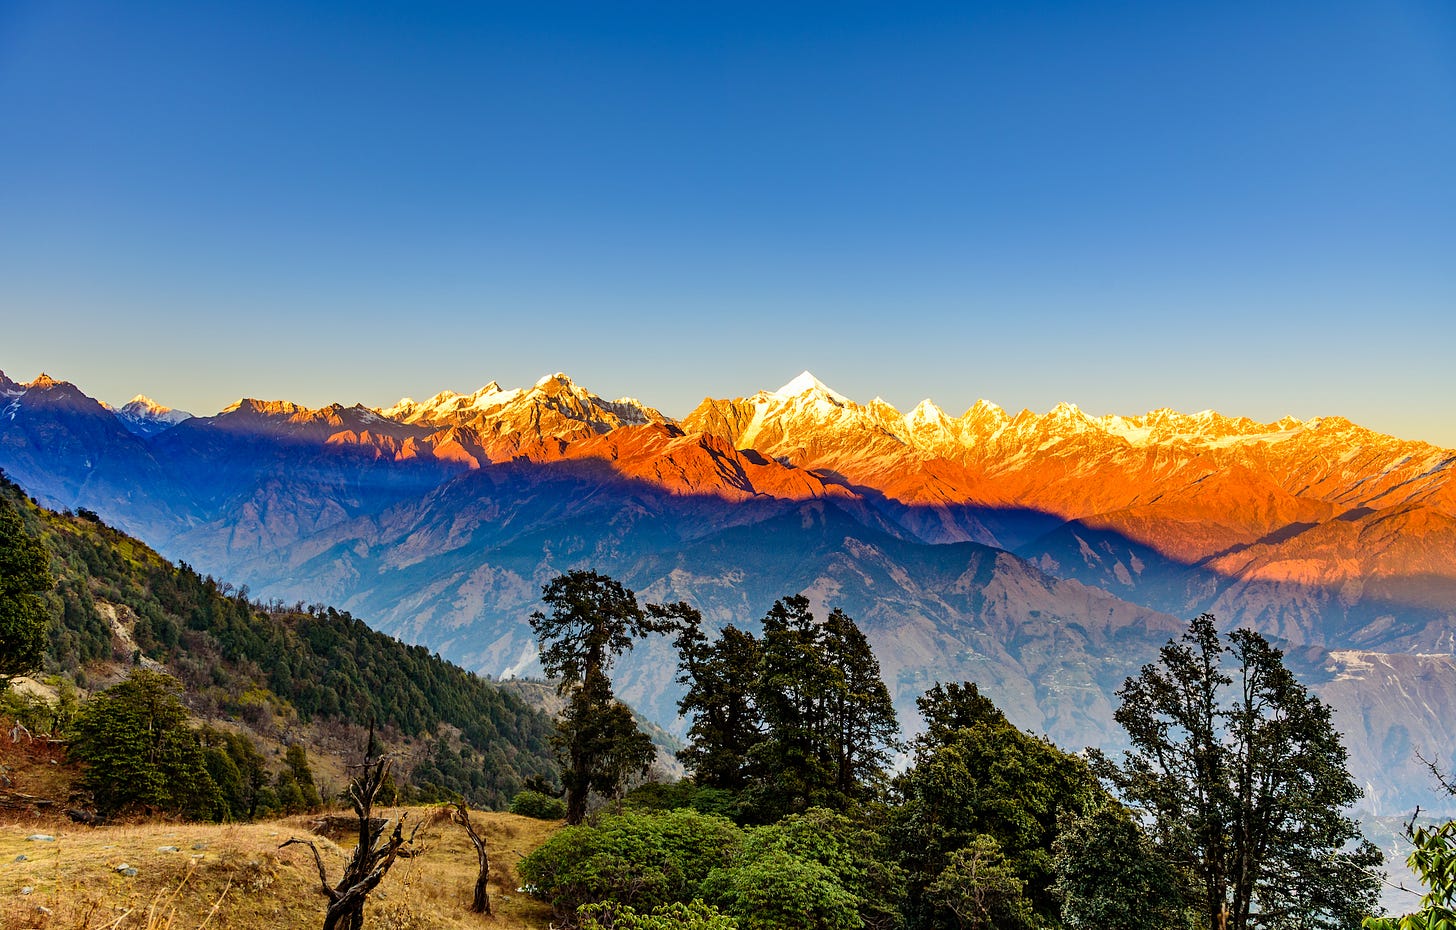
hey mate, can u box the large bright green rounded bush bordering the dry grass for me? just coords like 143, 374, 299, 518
517, 811, 741, 918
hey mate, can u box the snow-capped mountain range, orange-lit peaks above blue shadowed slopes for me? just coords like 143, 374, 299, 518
0, 366, 1456, 809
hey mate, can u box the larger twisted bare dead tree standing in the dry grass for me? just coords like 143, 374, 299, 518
278, 723, 419, 930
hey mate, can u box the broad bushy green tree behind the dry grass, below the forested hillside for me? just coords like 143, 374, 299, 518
70, 668, 227, 819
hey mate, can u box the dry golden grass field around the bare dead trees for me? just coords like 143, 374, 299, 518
0, 808, 561, 930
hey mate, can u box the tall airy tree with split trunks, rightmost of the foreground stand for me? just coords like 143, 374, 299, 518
1108, 614, 1380, 930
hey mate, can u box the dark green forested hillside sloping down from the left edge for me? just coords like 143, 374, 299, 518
0, 479, 555, 808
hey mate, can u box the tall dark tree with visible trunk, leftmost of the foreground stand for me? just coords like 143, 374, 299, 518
530, 569, 667, 824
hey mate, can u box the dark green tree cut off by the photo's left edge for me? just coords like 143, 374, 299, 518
0, 489, 55, 687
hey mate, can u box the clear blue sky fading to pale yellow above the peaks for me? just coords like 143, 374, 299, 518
0, 0, 1456, 447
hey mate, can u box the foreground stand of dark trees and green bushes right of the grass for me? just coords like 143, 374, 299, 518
520, 571, 1380, 930
